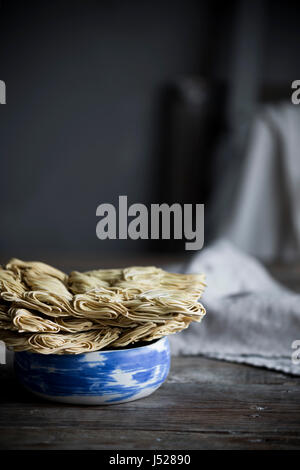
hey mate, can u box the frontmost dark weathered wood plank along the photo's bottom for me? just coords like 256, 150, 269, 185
0, 426, 300, 450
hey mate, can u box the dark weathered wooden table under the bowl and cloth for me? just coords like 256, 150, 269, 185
0, 258, 300, 450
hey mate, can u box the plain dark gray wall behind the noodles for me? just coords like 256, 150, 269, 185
0, 0, 299, 259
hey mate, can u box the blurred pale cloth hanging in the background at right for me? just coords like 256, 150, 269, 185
210, 102, 300, 260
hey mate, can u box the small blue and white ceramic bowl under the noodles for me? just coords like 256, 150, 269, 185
14, 337, 170, 405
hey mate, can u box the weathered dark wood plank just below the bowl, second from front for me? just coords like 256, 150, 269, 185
0, 403, 300, 435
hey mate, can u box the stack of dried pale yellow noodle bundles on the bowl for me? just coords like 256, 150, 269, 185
0, 259, 205, 354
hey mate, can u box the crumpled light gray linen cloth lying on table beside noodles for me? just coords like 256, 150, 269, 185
170, 240, 300, 375
